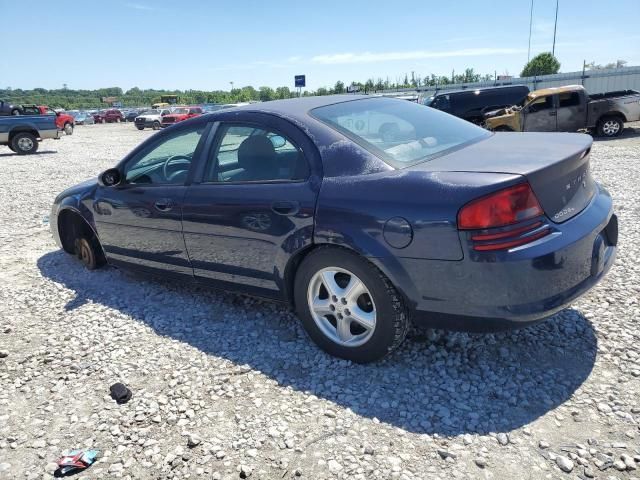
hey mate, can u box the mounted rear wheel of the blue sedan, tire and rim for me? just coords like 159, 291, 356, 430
294, 247, 409, 363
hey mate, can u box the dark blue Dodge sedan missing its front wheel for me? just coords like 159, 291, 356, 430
51, 96, 618, 362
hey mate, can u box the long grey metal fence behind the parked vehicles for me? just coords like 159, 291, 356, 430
378, 66, 640, 96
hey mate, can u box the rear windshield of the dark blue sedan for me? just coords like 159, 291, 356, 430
311, 98, 491, 168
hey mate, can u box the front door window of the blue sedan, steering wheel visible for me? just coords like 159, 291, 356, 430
123, 125, 204, 185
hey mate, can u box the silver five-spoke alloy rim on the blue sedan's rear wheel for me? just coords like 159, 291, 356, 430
307, 267, 377, 347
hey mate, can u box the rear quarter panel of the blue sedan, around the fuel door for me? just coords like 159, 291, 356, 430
314, 170, 522, 304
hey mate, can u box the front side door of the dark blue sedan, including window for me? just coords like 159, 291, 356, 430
93, 122, 206, 277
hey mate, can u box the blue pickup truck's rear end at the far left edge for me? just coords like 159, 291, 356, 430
0, 115, 60, 155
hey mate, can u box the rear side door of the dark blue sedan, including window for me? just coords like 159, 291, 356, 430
183, 113, 321, 297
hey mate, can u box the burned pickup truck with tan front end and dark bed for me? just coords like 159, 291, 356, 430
485, 85, 640, 137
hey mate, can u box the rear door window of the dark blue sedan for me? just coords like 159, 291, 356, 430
204, 124, 309, 182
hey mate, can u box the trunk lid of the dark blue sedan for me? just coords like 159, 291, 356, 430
411, 132, 596, 223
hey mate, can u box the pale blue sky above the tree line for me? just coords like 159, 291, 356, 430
0, 0, 640, 90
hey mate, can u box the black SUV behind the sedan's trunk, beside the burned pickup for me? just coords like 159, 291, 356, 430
424, 85, 529, 125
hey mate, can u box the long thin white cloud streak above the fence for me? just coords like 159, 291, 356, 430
311, 48, 525, 65
